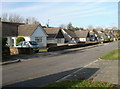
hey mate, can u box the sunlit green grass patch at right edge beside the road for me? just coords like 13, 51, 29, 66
100, 49, 120, 60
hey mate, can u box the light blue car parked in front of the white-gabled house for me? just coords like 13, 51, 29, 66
16, 41, 39, 52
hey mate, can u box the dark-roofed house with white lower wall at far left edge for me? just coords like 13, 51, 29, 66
0, 22, 23, 46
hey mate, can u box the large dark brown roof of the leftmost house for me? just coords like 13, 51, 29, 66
0, 22, 23, 37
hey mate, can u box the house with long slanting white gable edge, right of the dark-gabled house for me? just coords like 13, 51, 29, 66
62, 29, 78, 43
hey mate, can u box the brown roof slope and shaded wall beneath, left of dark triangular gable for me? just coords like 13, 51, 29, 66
44, 27, 59, 38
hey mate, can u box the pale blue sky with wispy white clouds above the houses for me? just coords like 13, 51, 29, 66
0, 1, 118, 28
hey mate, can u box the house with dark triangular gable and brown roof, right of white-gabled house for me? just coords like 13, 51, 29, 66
43, 27, 65, 44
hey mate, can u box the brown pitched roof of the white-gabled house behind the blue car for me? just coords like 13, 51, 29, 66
18, 24, 40, 36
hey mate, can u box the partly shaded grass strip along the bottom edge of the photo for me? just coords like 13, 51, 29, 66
40, 80, 116, 89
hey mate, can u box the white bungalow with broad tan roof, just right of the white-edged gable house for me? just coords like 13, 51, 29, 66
75, 30, 90, 42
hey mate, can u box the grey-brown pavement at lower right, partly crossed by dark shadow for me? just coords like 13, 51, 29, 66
57, 59, 119, 85
